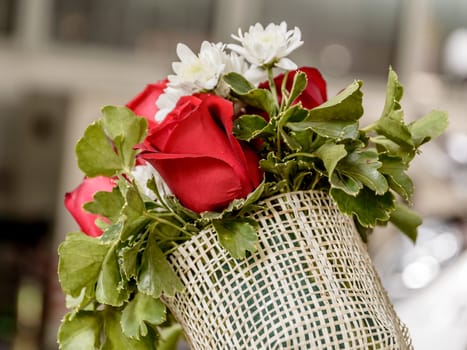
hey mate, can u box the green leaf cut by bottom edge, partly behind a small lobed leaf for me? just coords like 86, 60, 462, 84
101, 310, 156, 350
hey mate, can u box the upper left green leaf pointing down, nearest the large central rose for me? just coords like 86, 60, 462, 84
102, 106, 147, 169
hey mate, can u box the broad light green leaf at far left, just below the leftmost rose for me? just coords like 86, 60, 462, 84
58, 232, 109, 297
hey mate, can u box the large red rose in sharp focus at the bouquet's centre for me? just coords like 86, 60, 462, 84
140, 94, 262, 213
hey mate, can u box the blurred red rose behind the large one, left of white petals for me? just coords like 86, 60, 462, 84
126, 80, 168, 125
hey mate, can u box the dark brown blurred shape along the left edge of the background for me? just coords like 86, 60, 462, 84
0, 89, 67, 350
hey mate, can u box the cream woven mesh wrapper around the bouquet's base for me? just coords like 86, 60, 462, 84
165, 191, 412, 350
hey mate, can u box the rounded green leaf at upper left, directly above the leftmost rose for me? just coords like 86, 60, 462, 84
75, 121, 123, 177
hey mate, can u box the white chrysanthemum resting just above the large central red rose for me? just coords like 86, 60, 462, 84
155, 41, 248, 121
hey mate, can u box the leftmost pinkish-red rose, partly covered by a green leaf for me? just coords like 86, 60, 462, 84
65, 176, 116, 237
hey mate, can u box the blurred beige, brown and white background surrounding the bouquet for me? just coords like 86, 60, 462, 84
0, 0, 467, 350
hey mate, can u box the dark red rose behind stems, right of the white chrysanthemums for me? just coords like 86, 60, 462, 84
259, 67, 327, 109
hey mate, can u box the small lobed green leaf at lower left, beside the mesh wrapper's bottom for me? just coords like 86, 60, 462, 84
122, 293, 166, 339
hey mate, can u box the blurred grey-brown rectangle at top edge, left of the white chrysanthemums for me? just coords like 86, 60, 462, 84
53, 0, 214, 48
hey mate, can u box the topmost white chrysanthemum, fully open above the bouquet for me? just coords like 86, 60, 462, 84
228, 22, 303, 70
